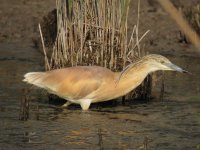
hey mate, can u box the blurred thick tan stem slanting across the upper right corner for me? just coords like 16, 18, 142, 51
158, 0, 200, 52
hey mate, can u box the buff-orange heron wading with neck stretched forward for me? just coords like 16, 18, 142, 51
23, 54, 186, 110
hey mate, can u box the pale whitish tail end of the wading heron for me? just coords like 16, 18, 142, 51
23, 72, 46, 88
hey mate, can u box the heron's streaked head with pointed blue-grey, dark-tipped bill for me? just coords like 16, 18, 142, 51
142, 54, 188, 73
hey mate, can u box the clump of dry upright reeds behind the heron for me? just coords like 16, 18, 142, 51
40, 0, 151, 101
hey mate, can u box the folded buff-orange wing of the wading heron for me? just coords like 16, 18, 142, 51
43, 67, 113, 100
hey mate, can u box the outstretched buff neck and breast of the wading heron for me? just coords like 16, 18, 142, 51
90, 63, 151, 102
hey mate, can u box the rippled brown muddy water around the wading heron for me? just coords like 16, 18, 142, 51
0, 43, 200, 150
